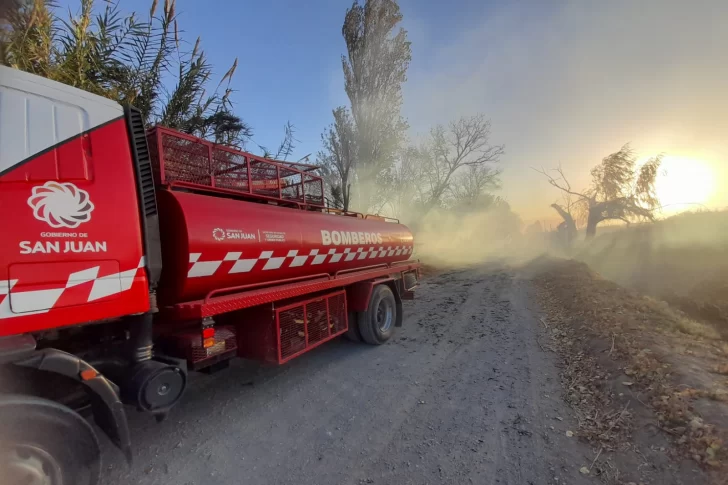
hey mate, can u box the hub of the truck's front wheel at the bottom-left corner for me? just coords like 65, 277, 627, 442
0, 445, 63, 485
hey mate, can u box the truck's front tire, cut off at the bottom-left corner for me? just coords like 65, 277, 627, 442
0, 395, 101, 485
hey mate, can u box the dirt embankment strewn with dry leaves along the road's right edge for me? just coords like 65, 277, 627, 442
527, 259, 728, 483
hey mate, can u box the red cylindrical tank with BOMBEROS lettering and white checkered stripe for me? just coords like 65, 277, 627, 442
157, 190, 413, 304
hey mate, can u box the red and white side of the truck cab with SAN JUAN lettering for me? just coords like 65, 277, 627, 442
0, 66, 149, 336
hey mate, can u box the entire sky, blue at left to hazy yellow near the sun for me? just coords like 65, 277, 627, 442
61, 0, 728, 220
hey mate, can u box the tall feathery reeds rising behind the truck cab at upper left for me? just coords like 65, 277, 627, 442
0, 0, 295, 159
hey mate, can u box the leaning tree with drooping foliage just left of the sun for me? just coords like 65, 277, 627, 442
536, 144, 662, 239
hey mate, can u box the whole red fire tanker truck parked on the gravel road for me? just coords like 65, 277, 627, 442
0, 66, 419, 485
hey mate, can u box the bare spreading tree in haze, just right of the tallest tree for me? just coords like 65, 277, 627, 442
421, 115, 504, 213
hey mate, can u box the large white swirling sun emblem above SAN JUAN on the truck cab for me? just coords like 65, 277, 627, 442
28, 182, 94, 229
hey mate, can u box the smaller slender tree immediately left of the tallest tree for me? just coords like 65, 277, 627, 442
316, 106, 357, 210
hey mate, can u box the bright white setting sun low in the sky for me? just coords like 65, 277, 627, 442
655, 155, 715, 212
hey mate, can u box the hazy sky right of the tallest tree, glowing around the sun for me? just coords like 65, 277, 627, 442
406, 0, 728, 219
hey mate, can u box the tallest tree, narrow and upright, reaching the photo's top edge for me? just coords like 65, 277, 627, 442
341, 0, 411, 208
